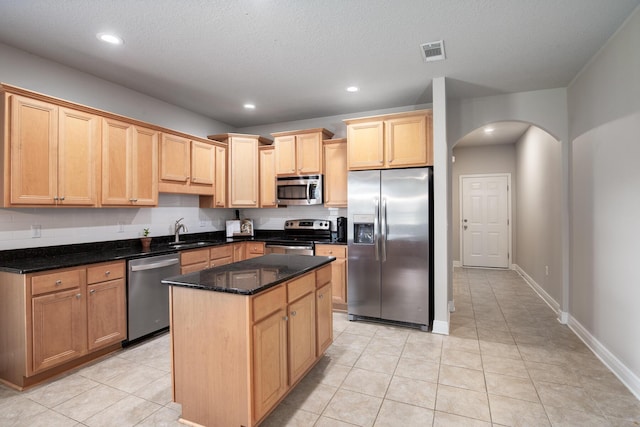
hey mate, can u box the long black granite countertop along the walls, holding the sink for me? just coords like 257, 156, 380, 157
0, 230, 345, 274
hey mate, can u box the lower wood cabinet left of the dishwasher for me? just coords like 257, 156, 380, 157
0, 261, 126, 389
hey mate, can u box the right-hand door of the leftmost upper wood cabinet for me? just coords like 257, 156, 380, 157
57, 107, 100, 206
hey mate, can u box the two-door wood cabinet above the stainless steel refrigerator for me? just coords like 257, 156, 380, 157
344, 110, 433, 170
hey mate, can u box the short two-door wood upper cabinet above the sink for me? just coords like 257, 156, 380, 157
158, 133, 216, 195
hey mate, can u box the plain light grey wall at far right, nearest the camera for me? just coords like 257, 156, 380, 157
568, 8, 640, 397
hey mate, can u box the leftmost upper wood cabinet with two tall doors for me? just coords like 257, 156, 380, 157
2, 93, 100, 207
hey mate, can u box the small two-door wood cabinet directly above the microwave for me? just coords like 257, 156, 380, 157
271, 128, 333, 176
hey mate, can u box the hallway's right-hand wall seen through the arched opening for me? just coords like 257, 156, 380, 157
514, 126, 563, 309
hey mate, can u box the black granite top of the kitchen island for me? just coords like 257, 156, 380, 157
162, 254, 335, 295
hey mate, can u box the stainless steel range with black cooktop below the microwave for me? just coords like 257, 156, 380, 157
265, 219, 331, 255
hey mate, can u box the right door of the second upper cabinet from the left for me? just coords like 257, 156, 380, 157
131, 126, 158, 206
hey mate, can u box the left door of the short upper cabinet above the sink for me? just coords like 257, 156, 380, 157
160, 133, 191, 184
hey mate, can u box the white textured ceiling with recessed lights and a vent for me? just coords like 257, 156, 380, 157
0, 0, 640, 127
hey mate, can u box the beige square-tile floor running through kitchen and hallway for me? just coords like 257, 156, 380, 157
0, 269, 640, 427
